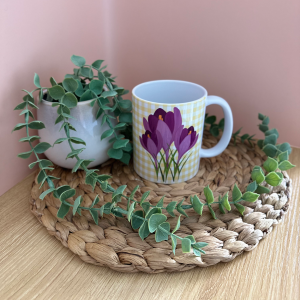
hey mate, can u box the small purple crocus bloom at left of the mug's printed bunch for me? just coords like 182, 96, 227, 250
140, 130, 163, 167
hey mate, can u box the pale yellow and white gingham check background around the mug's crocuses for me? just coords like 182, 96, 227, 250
132, 96, 206, 184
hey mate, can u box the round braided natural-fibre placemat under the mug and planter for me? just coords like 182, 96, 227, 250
30, 131, 291, 273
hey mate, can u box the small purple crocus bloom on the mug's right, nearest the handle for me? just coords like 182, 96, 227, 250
174, 126, 199, 163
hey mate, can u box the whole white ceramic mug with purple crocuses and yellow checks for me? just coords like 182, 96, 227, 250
132, 80, 233, 184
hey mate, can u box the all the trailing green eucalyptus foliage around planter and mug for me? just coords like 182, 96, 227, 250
13, 55, 294, 256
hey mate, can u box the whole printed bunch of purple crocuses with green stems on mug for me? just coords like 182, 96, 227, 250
140, 107, 199, 182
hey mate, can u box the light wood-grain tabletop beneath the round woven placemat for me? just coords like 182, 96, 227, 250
0, 149, 300, 300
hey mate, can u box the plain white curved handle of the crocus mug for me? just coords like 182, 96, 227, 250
200, 96, 233, 157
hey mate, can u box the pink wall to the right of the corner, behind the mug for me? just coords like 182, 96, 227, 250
108, 0, 300, 147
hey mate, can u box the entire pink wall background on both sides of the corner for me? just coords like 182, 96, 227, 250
0, 0, 300, 194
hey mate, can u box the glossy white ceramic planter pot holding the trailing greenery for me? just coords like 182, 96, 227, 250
37, 100, 116, 169
